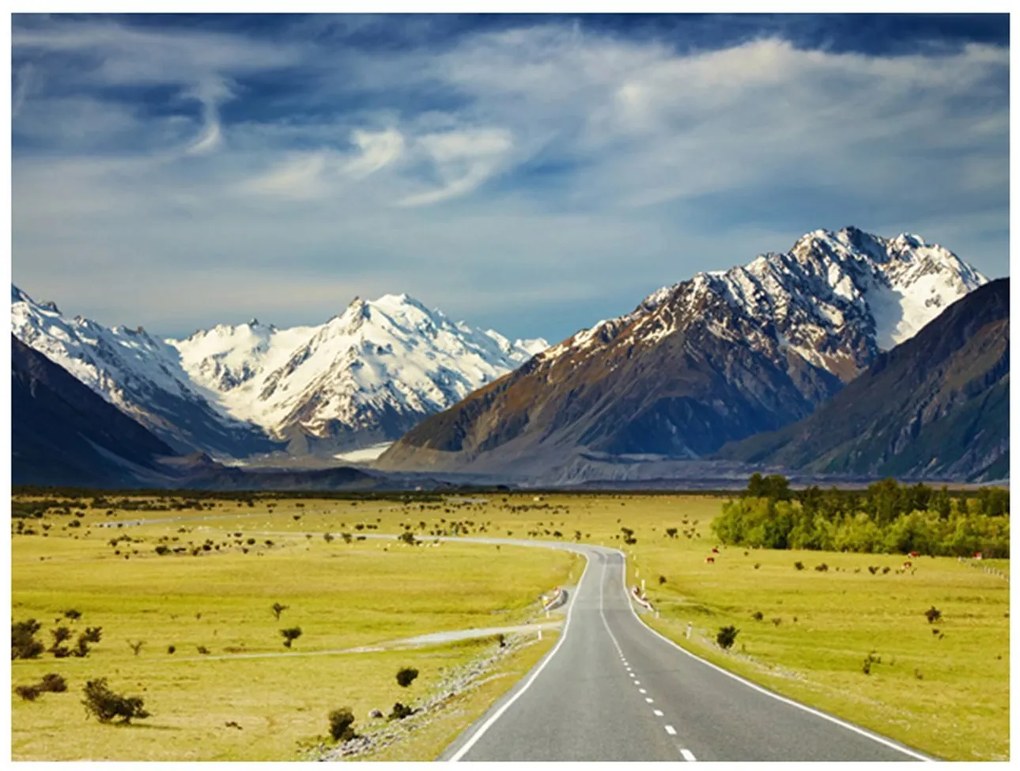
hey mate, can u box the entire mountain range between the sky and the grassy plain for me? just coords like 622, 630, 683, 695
11, 227, 1009, 489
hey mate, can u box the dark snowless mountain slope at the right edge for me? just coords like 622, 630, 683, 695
718, 278, 1010, 481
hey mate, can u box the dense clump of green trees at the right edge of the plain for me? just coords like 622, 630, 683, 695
712, 474, 1009, 557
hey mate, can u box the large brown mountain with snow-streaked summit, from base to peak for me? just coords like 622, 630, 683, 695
380, 227, 987, 478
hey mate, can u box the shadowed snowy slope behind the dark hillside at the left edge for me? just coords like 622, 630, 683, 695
11, 286, 273, 456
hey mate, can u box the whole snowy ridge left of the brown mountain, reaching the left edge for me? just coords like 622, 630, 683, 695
11, 286, 546, 458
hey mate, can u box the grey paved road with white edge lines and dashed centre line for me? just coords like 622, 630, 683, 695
443, 544, 927, 761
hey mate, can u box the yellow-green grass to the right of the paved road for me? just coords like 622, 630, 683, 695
607, 499, 1010, 761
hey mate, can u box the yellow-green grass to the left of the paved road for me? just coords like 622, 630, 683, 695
11, 497, 581, 760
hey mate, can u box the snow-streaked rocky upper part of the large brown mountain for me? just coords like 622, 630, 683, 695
542, 227, 988, 381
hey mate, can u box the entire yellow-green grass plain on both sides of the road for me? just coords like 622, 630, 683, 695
12, 494, 1010, 760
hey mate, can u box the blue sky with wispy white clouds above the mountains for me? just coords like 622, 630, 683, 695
10, 13, 1009, 342
